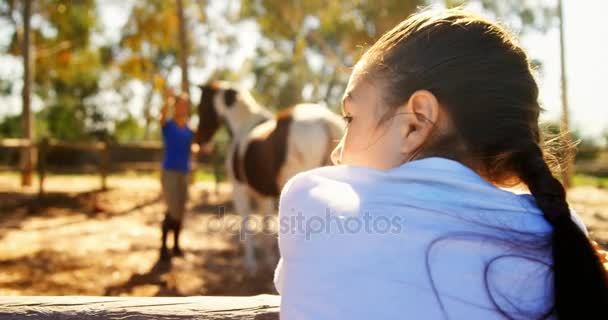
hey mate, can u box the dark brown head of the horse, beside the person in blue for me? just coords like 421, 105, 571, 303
196, 81, 238, 146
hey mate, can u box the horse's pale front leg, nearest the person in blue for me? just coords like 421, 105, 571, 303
232, 183, 258, 275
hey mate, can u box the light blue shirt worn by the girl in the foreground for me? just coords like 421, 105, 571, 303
274, 157, 586, 320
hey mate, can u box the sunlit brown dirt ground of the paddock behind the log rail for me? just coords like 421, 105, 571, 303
0, 173, 608, 296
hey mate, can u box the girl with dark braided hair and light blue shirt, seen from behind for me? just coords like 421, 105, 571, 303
274, 10, 608, 320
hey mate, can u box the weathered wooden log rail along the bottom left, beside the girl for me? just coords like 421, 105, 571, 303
0, 295, 280, 320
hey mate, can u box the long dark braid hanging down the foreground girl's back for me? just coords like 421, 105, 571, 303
516, 143, 608, 319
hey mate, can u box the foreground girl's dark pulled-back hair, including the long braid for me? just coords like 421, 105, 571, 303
359, 10, 608, 319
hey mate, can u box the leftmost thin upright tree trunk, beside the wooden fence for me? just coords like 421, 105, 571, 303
21, 0, 34, 186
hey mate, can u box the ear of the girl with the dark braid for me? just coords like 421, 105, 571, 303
397, 90, 440, 155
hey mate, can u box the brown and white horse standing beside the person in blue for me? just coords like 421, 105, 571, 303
197, 81, 345, 273
